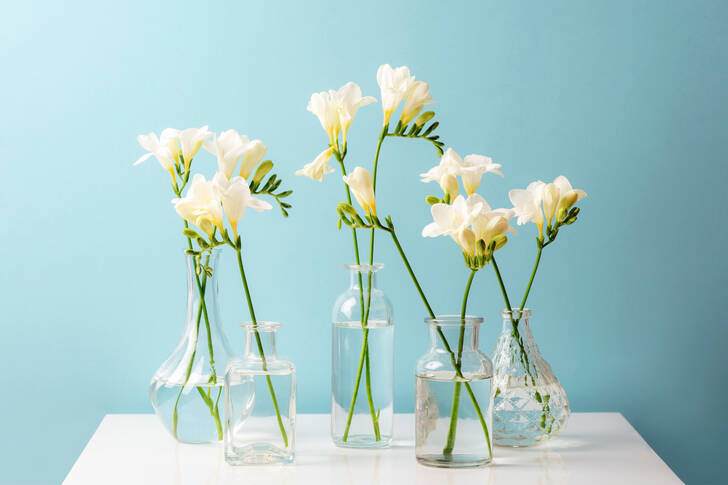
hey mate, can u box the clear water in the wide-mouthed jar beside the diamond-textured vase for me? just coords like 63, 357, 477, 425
415, 372, 492, 468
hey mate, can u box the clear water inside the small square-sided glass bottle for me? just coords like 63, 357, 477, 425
225, 369, 296, 465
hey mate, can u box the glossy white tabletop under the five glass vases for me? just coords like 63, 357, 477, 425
63, 413, 682, 485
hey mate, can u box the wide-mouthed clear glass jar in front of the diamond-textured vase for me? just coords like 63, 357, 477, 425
415, 315, 493, 468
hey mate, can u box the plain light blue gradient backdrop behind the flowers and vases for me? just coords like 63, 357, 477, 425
0, 1, 728, 484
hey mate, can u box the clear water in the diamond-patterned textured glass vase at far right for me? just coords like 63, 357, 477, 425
493, 379, 570, 446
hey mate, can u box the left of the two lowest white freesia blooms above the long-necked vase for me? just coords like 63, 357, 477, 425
172, 173, 224, 236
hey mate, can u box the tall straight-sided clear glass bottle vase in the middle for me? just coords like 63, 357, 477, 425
331, 264, 394, 448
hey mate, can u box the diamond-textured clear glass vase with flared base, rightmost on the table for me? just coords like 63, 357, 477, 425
493, 308, 571, 446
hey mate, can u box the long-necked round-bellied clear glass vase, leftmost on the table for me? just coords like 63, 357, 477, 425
150, 248, 232, 443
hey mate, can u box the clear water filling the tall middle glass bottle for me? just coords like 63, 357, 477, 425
331, 321, 394, 447
